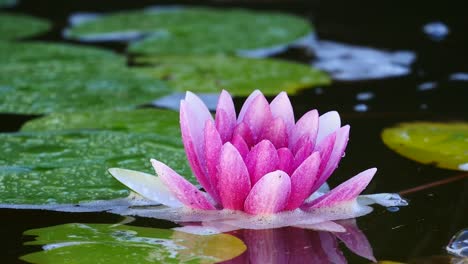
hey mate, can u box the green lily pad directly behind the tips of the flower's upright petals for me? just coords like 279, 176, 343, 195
137, 56, 330, 96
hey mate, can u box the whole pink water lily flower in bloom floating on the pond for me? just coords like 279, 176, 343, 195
109, 91, 404, 231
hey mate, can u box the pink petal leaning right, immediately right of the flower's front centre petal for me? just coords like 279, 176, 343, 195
285, 152, 320, 210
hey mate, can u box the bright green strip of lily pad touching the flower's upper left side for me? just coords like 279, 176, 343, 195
21, 109, 181, 135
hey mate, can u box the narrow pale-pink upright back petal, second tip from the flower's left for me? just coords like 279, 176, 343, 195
215, 90, 236, 143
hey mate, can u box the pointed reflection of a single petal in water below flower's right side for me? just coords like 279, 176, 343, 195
335, 219, 377, 262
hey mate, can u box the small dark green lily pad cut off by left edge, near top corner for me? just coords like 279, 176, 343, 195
0, 13, 51, 40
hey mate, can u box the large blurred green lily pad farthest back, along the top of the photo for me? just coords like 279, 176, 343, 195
67, 8, 312, 55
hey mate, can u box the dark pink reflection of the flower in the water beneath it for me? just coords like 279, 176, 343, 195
225, 219, 376, 264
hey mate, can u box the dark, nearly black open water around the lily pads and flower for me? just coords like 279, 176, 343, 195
0, 0, 468, 263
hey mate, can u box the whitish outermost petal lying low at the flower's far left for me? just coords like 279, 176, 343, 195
108, 168, 183, 207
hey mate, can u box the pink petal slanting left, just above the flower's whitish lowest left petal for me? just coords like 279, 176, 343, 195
151, 159, 215, 210
